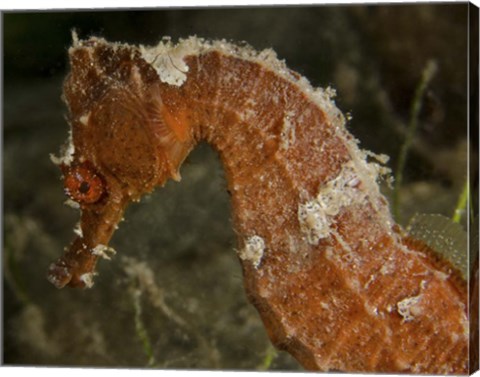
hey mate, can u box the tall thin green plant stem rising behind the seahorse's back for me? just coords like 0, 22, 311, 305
393, 60, 437, 222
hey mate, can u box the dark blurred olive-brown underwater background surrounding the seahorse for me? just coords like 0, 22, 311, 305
2, 3, 478, 370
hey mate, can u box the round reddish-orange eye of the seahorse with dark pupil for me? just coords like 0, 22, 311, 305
64, 163, 105, 204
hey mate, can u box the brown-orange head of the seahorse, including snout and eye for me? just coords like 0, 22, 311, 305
48, 38, 168, 288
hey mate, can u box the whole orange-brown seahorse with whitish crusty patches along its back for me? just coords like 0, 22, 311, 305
48, 34, 469, 374
